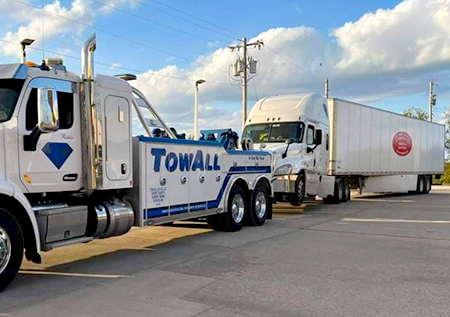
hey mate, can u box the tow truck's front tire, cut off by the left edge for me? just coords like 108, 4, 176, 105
0, 208, 24, 291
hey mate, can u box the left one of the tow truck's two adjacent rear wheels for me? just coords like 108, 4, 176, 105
207, 185, 247, 232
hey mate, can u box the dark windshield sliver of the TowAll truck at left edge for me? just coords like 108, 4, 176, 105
0, 79, 25, 122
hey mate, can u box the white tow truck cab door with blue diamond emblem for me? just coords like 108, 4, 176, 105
18, 78, 83, 193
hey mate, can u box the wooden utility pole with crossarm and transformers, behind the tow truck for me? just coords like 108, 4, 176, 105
229, 37, 264, 128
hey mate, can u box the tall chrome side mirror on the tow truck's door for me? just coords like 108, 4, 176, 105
37, 88, 59, 133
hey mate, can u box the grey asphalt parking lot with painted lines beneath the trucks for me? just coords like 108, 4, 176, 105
0, 187, 450, 317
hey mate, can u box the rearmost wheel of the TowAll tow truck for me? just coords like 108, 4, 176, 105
246, 182, 270, 226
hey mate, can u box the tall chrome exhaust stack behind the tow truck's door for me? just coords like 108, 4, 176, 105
81, 33, 103, 190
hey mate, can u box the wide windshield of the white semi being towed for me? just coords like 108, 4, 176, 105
243, 122, 305, 143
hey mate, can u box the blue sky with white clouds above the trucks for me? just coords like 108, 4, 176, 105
0, 0, 450, 133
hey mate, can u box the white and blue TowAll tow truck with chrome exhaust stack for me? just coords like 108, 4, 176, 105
0, 34, 273, 290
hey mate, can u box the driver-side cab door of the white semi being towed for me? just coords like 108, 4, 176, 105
305, 122, 320, 195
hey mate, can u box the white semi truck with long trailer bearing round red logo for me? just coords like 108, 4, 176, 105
243, 94, 445, 206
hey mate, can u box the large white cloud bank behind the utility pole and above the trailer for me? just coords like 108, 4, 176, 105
137, 0, 450, 135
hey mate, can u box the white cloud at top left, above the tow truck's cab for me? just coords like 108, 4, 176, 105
1, 0, 93, 56
